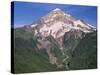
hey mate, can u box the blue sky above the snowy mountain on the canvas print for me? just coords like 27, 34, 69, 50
11, 1, 97, 28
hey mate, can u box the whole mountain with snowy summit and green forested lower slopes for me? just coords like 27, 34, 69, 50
14, 8, 97, 73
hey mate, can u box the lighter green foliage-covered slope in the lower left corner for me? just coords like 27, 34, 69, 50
15, 50, 56, 73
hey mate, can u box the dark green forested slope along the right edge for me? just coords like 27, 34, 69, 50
69, 32, 97, 69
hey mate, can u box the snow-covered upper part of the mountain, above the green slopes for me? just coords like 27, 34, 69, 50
31, 8, 94, 38
